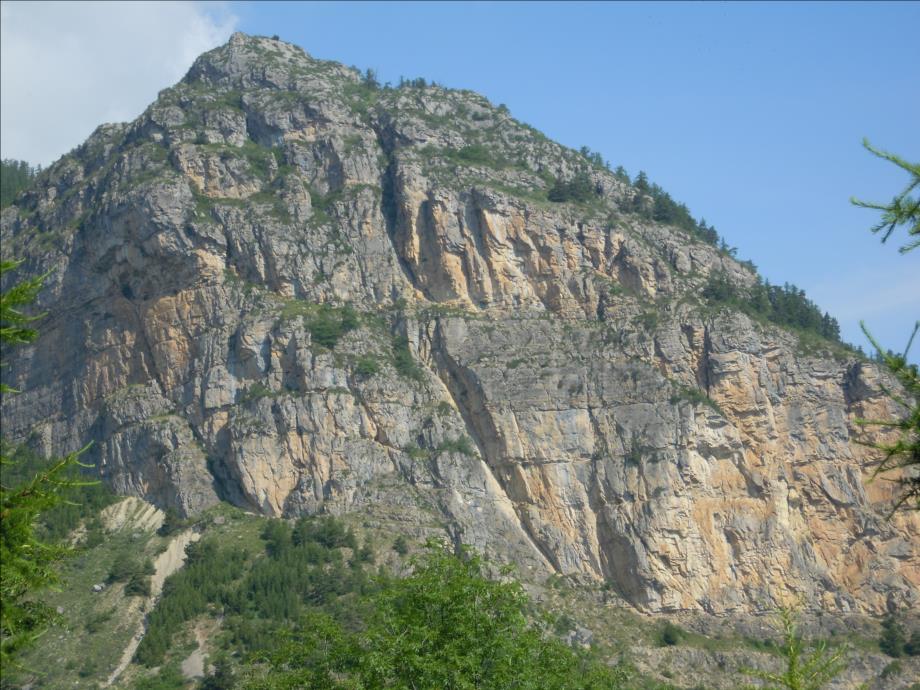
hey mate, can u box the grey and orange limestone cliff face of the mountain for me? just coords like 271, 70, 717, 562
2, 34, 920, 613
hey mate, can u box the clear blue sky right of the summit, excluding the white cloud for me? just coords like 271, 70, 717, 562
233, 3, 920, 357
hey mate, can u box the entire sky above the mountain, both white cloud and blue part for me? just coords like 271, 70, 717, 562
0, 0, 920, 360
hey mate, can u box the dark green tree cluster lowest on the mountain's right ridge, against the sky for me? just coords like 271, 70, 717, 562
702, 272, 840, 343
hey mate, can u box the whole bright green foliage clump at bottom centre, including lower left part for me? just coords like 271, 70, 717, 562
246, 545, 630, 690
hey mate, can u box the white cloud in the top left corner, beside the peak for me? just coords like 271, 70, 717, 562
0, 0, 237, 165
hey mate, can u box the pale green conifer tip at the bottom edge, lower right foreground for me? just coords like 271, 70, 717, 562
741, 608, 846, 690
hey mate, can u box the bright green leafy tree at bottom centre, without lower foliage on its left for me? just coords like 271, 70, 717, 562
350, 547, 613, 688
